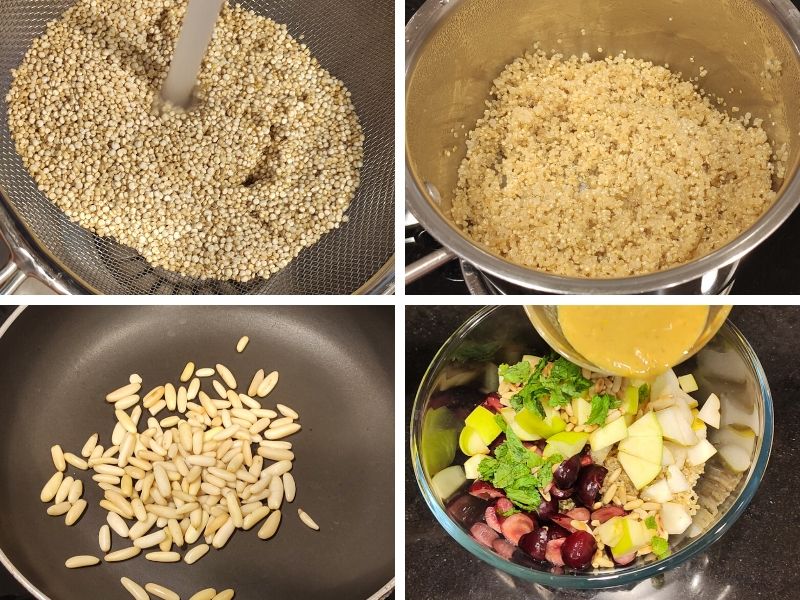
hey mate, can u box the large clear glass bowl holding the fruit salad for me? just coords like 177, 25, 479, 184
410, 306, 773, 589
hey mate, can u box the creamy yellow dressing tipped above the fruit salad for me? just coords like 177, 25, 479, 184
558, 306, 709, 379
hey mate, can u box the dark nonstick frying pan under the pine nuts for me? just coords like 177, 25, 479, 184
0, 306, 394, 600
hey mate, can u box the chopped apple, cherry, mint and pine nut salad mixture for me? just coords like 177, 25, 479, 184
432, 356, 752, 572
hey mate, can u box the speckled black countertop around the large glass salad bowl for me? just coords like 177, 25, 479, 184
405, 306, 800, 600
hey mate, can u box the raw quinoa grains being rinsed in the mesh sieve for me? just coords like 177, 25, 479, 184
7, 0, 364, 281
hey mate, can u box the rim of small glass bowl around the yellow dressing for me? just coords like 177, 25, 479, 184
524, 305, 731, 373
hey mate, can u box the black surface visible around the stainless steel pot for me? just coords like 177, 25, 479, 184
405, 0, 800, 295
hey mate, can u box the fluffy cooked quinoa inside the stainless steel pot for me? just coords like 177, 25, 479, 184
452, 49, 775, 278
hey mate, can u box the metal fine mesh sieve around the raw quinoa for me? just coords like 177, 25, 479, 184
0, 0, 394, 294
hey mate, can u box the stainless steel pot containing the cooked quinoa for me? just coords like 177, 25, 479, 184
406, 0, 800, 294
